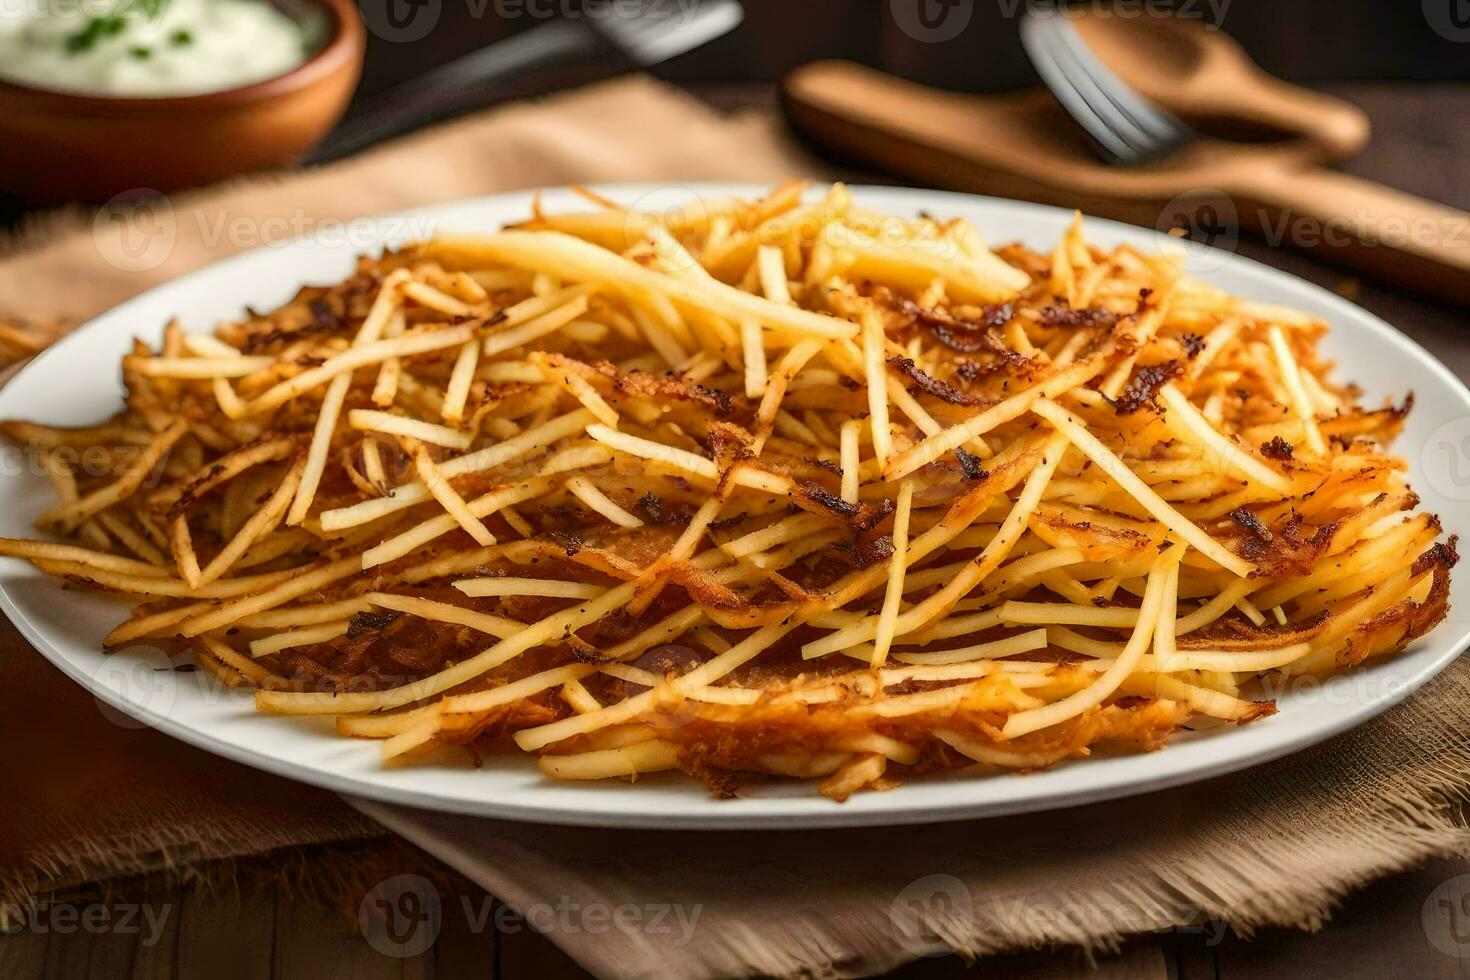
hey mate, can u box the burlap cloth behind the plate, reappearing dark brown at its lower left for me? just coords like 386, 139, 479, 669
0, 78, 813, 927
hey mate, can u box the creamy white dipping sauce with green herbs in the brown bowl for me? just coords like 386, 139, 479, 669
0, 0, 309, 98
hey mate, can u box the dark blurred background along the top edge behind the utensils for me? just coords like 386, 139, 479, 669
346, 0, 1470, 107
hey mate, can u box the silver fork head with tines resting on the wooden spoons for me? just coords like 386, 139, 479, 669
1020, 6, 1195, 166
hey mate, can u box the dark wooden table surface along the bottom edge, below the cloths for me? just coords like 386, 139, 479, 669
0, 861, 1470, 980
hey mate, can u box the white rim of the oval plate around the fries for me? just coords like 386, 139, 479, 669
0, 181, 1470, 830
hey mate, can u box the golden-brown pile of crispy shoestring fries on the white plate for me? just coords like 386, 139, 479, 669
0, 184, 1454, 799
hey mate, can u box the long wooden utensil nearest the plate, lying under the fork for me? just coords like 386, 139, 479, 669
782, 62, 1470, 306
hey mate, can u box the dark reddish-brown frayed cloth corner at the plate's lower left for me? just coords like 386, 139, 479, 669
0, 628, 382, 910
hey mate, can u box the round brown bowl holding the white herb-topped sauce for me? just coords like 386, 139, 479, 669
0, 0, 365, 202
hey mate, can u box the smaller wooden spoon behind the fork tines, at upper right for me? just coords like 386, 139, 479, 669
1072, 13, 1370, 162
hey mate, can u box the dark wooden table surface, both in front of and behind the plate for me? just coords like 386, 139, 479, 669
0, 84, 1470, 980
